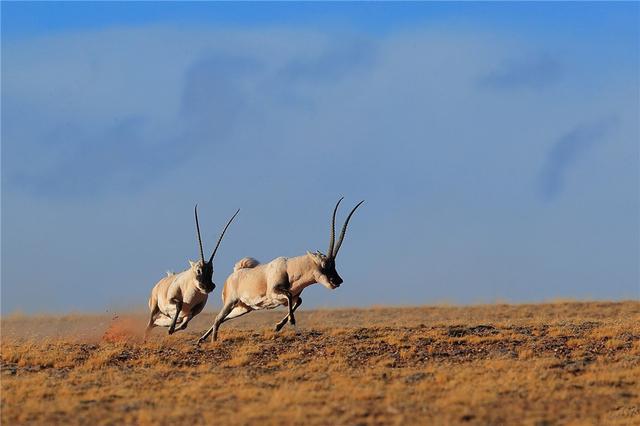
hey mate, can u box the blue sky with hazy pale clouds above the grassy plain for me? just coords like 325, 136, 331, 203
2, 2, 640, 313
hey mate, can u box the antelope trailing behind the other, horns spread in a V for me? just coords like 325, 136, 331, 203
145, 204, 240, 339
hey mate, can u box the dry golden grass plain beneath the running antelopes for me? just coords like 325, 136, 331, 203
1, 302, 640, 425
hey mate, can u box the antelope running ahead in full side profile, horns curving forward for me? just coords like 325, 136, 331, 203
197, 197, 364, 344
